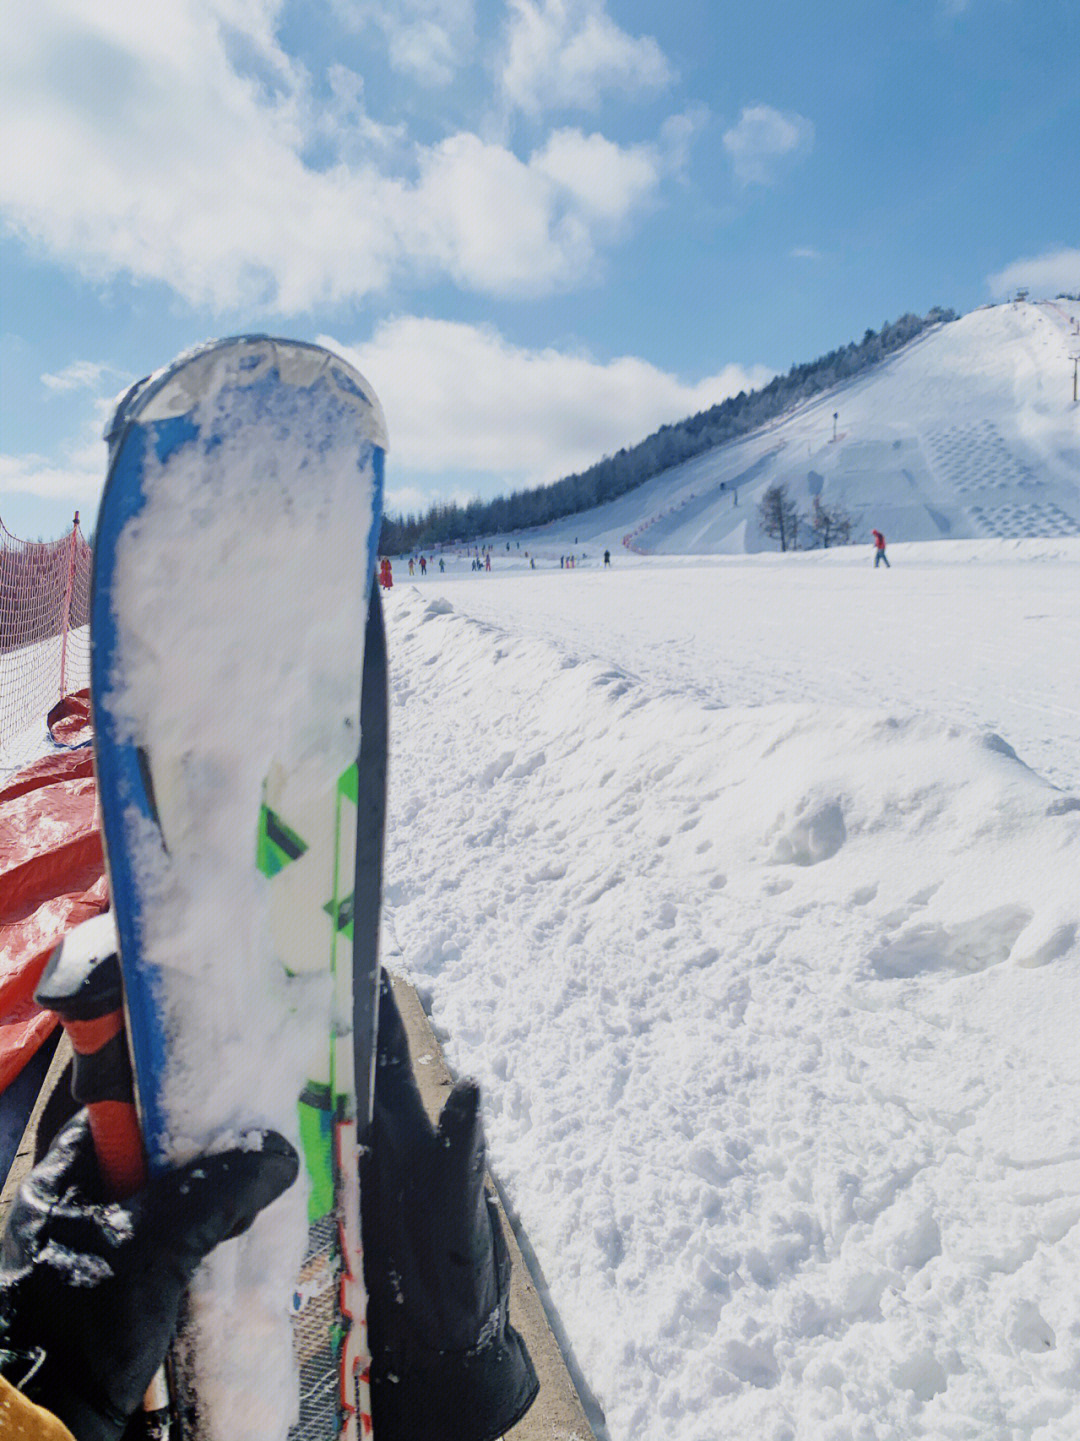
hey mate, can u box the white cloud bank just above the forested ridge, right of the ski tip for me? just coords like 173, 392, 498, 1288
322, 316, 773, 490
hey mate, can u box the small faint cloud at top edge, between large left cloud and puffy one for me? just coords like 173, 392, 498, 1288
335, 0, 476, 85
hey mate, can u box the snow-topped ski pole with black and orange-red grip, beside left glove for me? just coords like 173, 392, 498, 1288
35, 912, 172, 1441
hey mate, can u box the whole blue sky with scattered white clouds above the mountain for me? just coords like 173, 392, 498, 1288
0, 0, 1080, 536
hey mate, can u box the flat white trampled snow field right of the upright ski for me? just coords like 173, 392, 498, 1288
385, 540, 1080, 1441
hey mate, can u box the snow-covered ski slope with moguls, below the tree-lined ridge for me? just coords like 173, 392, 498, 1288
501, 300, 1080, 555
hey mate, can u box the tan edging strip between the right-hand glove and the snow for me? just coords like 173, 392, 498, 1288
389, 973, 597, 1441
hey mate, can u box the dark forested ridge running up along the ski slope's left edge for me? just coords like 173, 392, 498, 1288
379, 305, 956, 555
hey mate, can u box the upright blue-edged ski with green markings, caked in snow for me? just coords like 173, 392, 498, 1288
91, 337, 385, 1441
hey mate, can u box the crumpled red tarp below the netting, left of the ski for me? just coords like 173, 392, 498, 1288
0, 690, 108, 1091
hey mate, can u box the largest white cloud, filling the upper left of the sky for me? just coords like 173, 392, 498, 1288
0, 0, 666, 313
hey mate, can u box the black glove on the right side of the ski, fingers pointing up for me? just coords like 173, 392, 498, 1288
360, 973, 538, 1441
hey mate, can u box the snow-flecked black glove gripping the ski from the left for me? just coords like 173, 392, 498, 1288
0, 1112, 300, 1441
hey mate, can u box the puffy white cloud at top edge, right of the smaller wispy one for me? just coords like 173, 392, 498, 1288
502, 0, 675, 115
